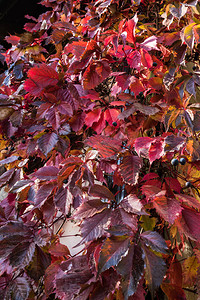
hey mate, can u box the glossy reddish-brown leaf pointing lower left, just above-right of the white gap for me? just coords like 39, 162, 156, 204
73, 199, 108, 219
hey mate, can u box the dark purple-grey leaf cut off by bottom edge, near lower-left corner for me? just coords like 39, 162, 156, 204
9, 277, 30, 300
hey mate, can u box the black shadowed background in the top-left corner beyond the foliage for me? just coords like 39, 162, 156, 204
0, 0, 48, 48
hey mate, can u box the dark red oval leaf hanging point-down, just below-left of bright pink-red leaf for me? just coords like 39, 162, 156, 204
119, 154, 142, 185
